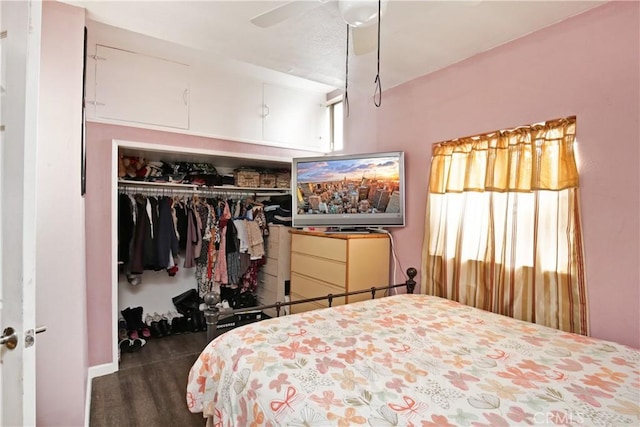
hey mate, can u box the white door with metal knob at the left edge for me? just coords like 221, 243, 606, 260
0, 0, 42, 426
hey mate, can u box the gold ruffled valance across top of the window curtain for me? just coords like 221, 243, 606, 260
429, 117, 578, 194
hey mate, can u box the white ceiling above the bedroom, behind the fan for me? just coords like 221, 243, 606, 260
64, 0, 604, 91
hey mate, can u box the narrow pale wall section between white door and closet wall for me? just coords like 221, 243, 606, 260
35, 1, 89, 426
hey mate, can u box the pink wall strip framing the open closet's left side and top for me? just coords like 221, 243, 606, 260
85, 123, 317, 366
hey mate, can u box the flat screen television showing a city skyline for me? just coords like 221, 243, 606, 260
291, 151, 405, 232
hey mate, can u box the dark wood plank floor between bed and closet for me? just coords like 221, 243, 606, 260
89, 332, 207, 427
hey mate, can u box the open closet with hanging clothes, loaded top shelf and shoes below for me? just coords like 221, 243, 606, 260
112, 141, 291, 370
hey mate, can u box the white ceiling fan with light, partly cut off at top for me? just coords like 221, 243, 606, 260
251, 0, 388, 55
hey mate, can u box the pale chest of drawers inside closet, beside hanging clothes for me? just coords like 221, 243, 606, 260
256, 224, 291, 317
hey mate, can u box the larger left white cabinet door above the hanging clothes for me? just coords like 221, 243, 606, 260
95, 45, 189, 129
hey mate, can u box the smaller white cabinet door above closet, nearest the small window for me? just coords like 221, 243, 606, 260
262, 84, 329, 149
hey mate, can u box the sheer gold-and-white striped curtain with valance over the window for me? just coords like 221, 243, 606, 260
422, 117, 589, 335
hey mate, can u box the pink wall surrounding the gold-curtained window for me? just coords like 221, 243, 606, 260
346, 2, 640, 348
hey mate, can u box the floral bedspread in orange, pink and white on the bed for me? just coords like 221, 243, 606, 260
186, 295, 640, 426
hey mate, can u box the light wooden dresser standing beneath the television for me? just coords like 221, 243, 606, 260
291, 230, 391, 313
